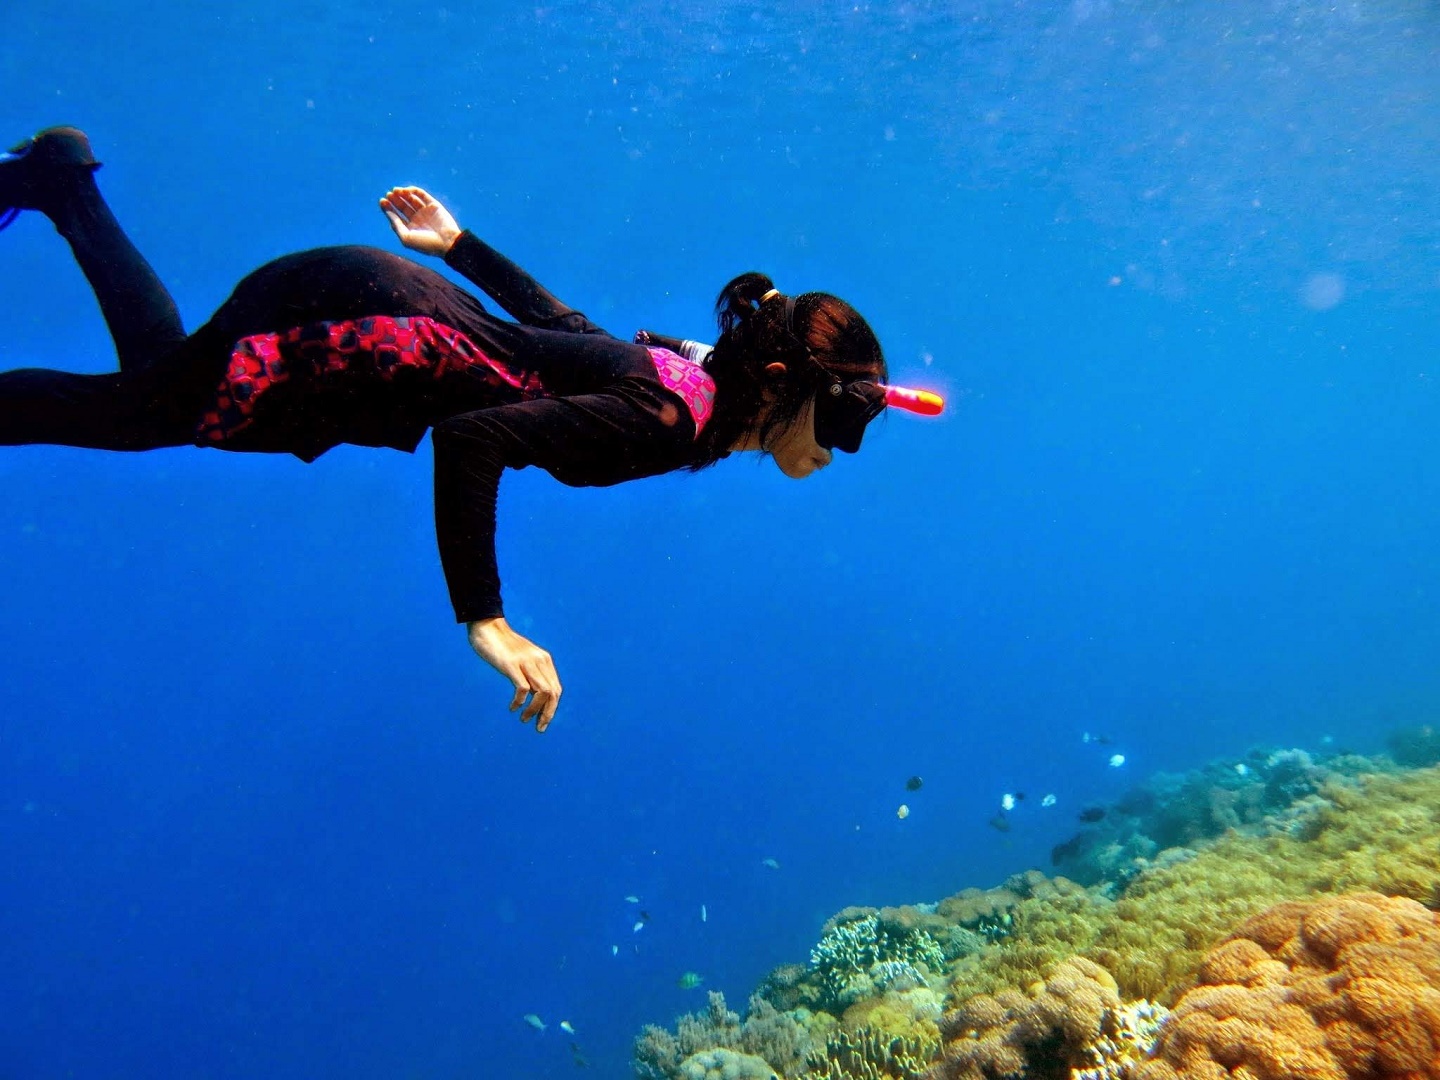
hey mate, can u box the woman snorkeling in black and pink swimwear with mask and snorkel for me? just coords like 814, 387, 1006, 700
0, 128, 939, 732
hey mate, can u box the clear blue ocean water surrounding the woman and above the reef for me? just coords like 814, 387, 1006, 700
0, 0, 1440, 1080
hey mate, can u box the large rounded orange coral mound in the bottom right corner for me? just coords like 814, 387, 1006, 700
1135, 893, 1440, 1080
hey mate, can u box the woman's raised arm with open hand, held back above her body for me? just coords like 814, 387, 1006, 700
380, 187, 605, 334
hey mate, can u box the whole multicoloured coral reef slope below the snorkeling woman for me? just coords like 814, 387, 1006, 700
636, 754, 1440, 1080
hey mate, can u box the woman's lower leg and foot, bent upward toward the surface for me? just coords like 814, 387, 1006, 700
0, 128, 184, 373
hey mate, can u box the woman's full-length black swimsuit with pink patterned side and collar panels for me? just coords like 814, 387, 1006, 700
0, 184, 714, 622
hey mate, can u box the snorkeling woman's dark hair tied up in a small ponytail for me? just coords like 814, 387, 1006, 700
693, 271, 887, 468
